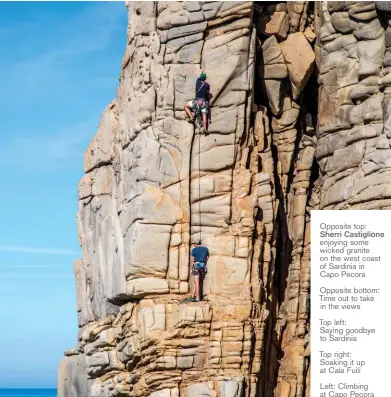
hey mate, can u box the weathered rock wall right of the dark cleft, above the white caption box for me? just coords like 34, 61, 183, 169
317, 2, 391, 209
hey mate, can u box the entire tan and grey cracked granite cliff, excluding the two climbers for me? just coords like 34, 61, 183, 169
58, 1, 391, 397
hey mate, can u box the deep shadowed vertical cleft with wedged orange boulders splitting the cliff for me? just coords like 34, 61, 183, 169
255, 2, 318, 397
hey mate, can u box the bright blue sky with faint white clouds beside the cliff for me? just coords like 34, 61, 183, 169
0, 2, 127, 388
